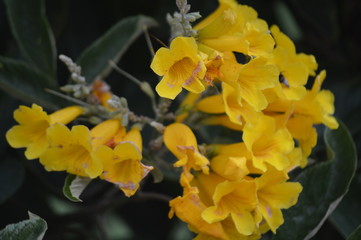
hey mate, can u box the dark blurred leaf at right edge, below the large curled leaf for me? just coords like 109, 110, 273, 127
330, 173, 361, 239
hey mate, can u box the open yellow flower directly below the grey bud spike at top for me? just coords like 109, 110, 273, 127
151, 37, 206, 99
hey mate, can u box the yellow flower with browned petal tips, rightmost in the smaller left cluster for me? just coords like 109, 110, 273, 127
95, 128, 153, 197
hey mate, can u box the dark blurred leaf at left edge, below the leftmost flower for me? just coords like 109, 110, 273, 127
0, 158, 24, 204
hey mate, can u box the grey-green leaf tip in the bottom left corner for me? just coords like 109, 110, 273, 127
0, 212, 48, 240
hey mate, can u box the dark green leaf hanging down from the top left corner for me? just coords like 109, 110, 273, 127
5, 0, 56, 78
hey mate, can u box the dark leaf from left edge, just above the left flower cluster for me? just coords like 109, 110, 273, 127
0, 57, 59, 109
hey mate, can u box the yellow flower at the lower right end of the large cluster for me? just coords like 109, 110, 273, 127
255, 169, 302, 233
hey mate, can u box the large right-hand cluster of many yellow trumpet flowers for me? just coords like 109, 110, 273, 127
151, 0, 338, 239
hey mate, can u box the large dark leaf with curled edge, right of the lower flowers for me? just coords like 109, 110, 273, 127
273, 123, 357, 240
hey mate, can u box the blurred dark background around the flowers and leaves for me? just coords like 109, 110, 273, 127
0, 0, 361, 240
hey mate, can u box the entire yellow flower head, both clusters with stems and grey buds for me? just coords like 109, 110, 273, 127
6, 0, 338, 240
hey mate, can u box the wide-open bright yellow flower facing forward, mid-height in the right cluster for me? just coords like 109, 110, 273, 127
243, 116, 294, 172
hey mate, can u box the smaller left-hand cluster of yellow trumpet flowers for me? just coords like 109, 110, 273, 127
6, 101, 153, 196
